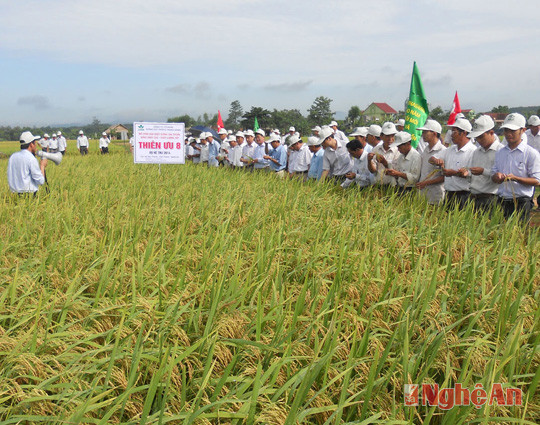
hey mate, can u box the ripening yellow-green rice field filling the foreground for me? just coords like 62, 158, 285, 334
0, 141, 540, 425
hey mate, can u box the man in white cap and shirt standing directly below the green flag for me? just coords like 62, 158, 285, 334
386, 131, 422, 194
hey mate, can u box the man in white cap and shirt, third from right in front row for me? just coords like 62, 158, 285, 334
430, 118, 476, 209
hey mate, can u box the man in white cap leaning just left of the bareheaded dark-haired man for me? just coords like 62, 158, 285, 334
319, 127, 353, 184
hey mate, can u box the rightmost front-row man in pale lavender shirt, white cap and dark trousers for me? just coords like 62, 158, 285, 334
491, 113, 540, 222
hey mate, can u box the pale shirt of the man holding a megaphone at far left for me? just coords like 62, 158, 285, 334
7, 149, 45, 193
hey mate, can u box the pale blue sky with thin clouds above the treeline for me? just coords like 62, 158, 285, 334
0, 0, 540, 126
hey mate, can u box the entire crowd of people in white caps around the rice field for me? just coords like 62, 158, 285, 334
8, 113, 540, 220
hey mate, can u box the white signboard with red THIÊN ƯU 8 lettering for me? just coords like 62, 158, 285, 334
133, 122, 186, 164
